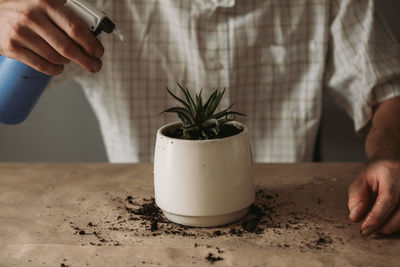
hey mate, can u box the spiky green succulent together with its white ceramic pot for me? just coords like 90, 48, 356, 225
154, 84, 255, 227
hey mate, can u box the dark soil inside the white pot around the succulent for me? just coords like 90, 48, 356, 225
164, 124, 243, 140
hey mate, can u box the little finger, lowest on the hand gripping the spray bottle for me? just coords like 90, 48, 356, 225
9, 47, 64, 75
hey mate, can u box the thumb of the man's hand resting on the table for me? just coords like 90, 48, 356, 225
348, 177, 371, 222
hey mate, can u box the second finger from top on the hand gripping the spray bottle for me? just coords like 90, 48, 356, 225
25, 7, 101, 72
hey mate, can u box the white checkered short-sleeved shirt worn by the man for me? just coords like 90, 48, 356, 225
55, 0, 400, 162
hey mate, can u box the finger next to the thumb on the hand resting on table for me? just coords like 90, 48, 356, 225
361, 180, 399, 236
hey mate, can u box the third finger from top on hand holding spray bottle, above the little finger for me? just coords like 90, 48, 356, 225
19, 28, 69, 65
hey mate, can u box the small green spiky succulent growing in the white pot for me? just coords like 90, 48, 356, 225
160, 83, 246, 140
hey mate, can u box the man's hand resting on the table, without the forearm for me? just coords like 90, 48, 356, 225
348, 160, 400, 236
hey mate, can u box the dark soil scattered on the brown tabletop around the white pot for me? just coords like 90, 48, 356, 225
64, 188, 350, 253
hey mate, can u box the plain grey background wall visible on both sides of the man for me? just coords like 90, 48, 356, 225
0, 0, 400, 162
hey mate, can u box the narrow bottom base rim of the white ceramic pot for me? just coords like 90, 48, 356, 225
162, 208, 249, 227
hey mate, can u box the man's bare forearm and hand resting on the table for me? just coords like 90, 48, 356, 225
348, 97, 400, 236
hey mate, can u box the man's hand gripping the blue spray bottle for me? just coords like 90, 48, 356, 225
0, 0, 104, 75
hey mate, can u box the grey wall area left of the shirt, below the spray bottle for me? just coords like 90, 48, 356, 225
0, 82, 107, 162
